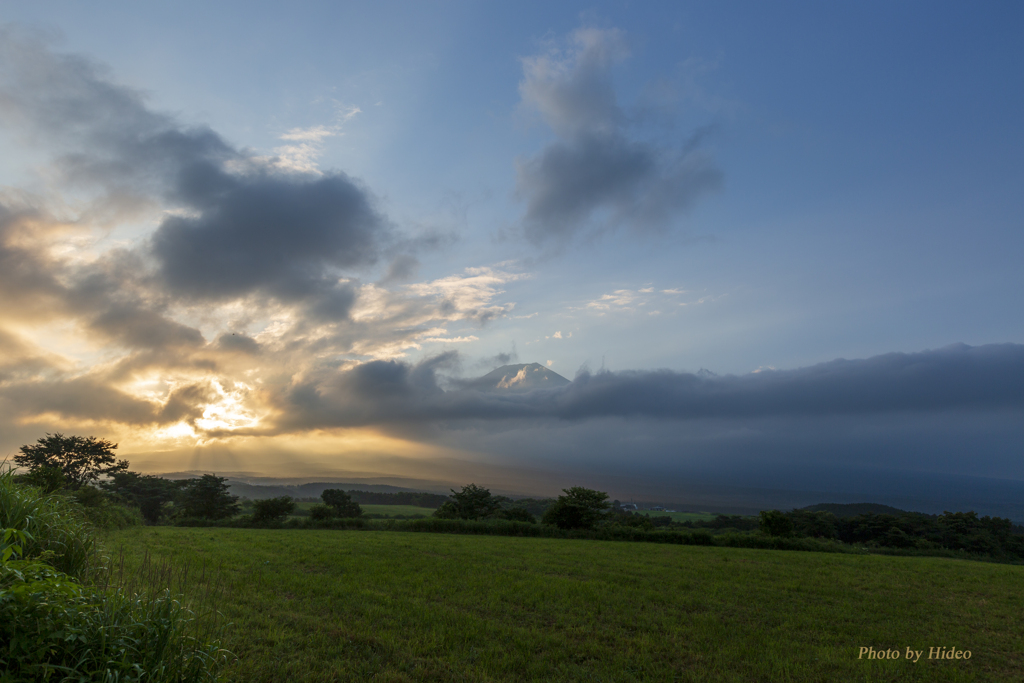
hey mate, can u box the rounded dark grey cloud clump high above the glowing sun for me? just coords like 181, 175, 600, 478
153, 168, 384, 319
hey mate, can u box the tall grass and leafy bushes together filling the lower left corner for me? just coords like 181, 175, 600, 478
0, 471, 227, 683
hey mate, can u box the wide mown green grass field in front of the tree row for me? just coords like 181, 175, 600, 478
105, 527, 1024, 682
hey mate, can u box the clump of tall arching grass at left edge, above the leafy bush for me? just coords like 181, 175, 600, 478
0, 469, 96, 579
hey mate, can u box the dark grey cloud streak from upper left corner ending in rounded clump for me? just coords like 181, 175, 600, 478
0, 31, 390, 319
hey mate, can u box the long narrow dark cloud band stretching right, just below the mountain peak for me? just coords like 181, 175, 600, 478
266, 344, 1024, 427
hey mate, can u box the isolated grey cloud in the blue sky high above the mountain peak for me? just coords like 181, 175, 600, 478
516, 29, 721, 245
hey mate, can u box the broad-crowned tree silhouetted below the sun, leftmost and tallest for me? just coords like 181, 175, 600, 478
14, 433, 128, 488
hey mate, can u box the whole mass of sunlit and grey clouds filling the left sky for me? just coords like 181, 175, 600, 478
0, 30, 522, 448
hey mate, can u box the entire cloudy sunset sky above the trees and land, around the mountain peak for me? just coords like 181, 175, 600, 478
0, 0, 1024, 515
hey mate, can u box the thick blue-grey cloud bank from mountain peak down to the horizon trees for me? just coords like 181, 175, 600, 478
256, 344, 1024, 519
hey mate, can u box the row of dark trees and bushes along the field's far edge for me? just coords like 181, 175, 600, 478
14, 433, 1024, 560
